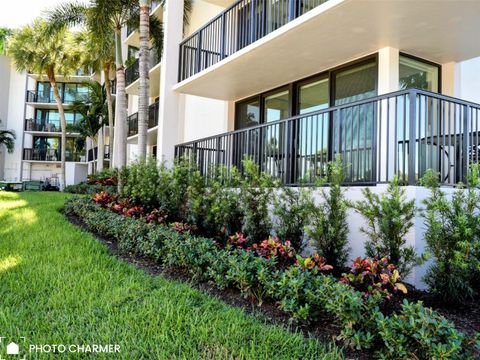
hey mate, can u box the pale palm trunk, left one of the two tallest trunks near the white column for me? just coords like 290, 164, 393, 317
113, 29, 127, 170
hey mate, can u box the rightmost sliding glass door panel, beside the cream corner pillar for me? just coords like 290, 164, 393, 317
333, 61, 377, 181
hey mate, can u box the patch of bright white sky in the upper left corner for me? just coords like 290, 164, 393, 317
0, 0, 69, 29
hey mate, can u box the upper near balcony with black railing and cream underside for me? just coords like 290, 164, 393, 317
174, 0, 480, 101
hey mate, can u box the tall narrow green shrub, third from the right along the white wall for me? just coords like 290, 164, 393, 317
306, 157, 348, 268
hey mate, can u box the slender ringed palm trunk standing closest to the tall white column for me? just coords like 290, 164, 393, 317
138, 0, 150, 160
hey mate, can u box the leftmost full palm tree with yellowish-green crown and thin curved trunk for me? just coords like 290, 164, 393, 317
7, 19, 81, 189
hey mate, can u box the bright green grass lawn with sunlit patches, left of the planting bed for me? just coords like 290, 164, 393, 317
0, 192, 342, 359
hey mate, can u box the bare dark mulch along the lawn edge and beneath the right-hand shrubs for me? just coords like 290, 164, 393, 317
66, 215, 480, 360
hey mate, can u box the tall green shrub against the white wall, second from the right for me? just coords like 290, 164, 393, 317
353, 178, 416, 277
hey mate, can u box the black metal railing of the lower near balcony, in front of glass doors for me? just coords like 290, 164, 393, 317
175, 89, 480, 185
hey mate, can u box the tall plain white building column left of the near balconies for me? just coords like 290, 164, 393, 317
157, 0, 183, 162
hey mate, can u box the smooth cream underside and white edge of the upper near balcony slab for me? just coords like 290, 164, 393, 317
175, 0, 480, 100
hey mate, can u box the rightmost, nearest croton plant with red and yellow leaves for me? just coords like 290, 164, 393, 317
341, 257, 407, 299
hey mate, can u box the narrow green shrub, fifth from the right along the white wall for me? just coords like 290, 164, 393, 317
239, 159, 275, 245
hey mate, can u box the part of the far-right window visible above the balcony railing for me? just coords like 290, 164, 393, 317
399, 55, 440, 92
